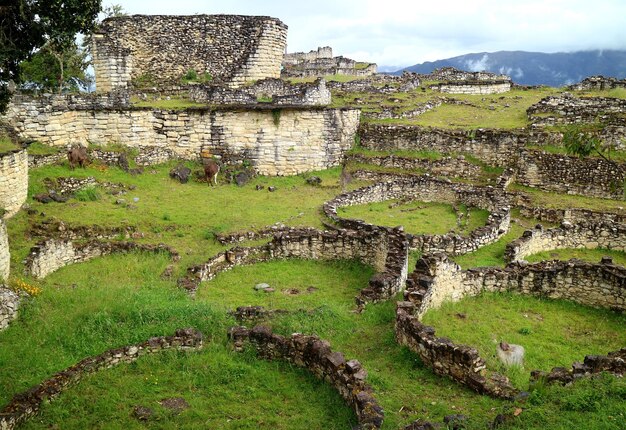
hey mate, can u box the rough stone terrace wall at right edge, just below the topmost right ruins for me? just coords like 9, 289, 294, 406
526, 93, 626, 126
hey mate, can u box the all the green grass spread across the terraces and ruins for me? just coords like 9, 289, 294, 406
0, 89, 626, 430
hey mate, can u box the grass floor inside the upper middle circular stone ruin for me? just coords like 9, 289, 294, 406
338, 200, 489, 234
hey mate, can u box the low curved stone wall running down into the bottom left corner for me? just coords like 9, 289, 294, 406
0, 328, 203, 430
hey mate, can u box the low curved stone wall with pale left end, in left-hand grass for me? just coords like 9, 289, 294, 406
24, 239, 179, 278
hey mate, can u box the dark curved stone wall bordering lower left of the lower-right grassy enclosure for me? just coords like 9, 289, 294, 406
395, 301, 518, 399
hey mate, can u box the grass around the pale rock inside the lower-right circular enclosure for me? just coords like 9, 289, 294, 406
423, 293, 626, 389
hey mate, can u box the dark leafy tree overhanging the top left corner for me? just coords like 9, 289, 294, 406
0, 0, 101, 113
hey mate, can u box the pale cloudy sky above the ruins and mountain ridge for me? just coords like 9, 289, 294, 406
114, 0, 626, 68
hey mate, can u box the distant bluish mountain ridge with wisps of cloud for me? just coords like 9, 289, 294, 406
393, 50, 626, 87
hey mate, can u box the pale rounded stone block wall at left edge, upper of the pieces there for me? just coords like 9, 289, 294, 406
0, 149, 28, 217
